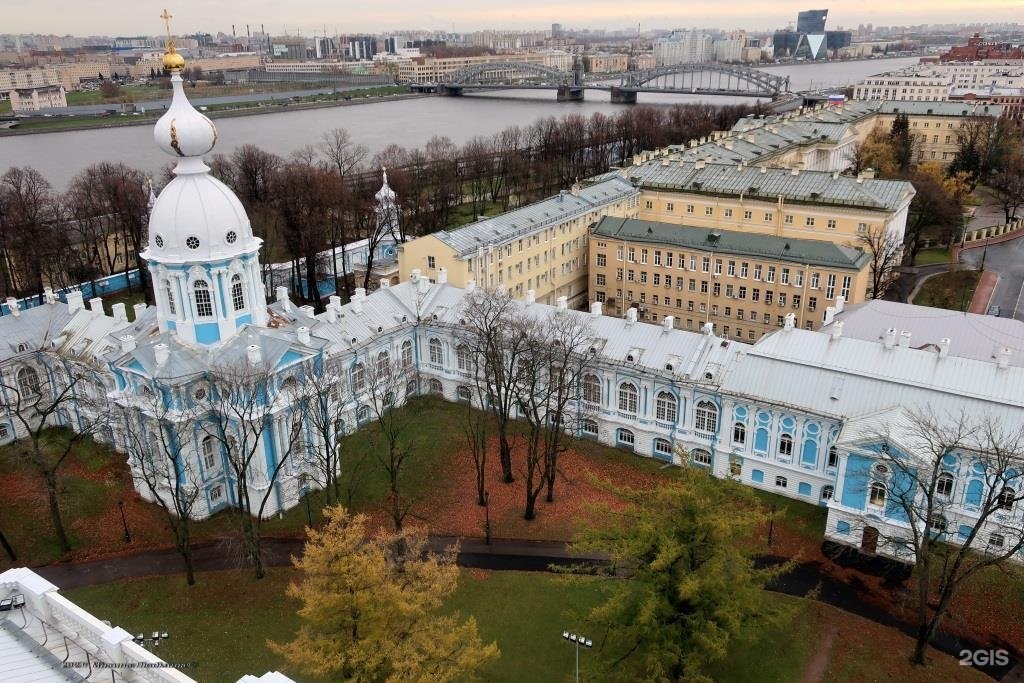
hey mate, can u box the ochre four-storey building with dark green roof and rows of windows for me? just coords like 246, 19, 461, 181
590, 217, 870, 343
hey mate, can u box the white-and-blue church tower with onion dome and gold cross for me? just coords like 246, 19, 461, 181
140, 20, 266, 346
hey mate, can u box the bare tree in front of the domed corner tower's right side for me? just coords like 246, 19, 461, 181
206, 360, 302, 579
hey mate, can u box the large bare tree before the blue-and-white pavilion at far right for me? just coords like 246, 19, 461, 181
864, 408, 1024, 665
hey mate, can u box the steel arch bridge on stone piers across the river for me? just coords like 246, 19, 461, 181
410, 61, 790, 104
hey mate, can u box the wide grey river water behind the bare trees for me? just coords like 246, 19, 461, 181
0, 57, 916, 189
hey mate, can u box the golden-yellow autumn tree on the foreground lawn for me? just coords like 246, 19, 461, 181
268, 507, 499, 683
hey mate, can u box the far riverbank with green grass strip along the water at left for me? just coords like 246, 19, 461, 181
0, 92, 425, 137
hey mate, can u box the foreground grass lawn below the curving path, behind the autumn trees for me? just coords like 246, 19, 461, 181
63, 568, 985, 683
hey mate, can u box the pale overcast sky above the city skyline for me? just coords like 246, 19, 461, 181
0, 0, 1024, 36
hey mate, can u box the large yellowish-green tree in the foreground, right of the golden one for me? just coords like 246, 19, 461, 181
572, 466, 787, 681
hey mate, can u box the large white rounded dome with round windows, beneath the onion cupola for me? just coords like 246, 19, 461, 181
143, 159, 260, 263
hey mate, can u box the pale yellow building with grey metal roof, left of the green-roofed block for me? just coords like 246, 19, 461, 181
398, 175, 639, 307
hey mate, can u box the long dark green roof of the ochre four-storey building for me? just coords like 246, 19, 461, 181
593, 216, 870, 270
